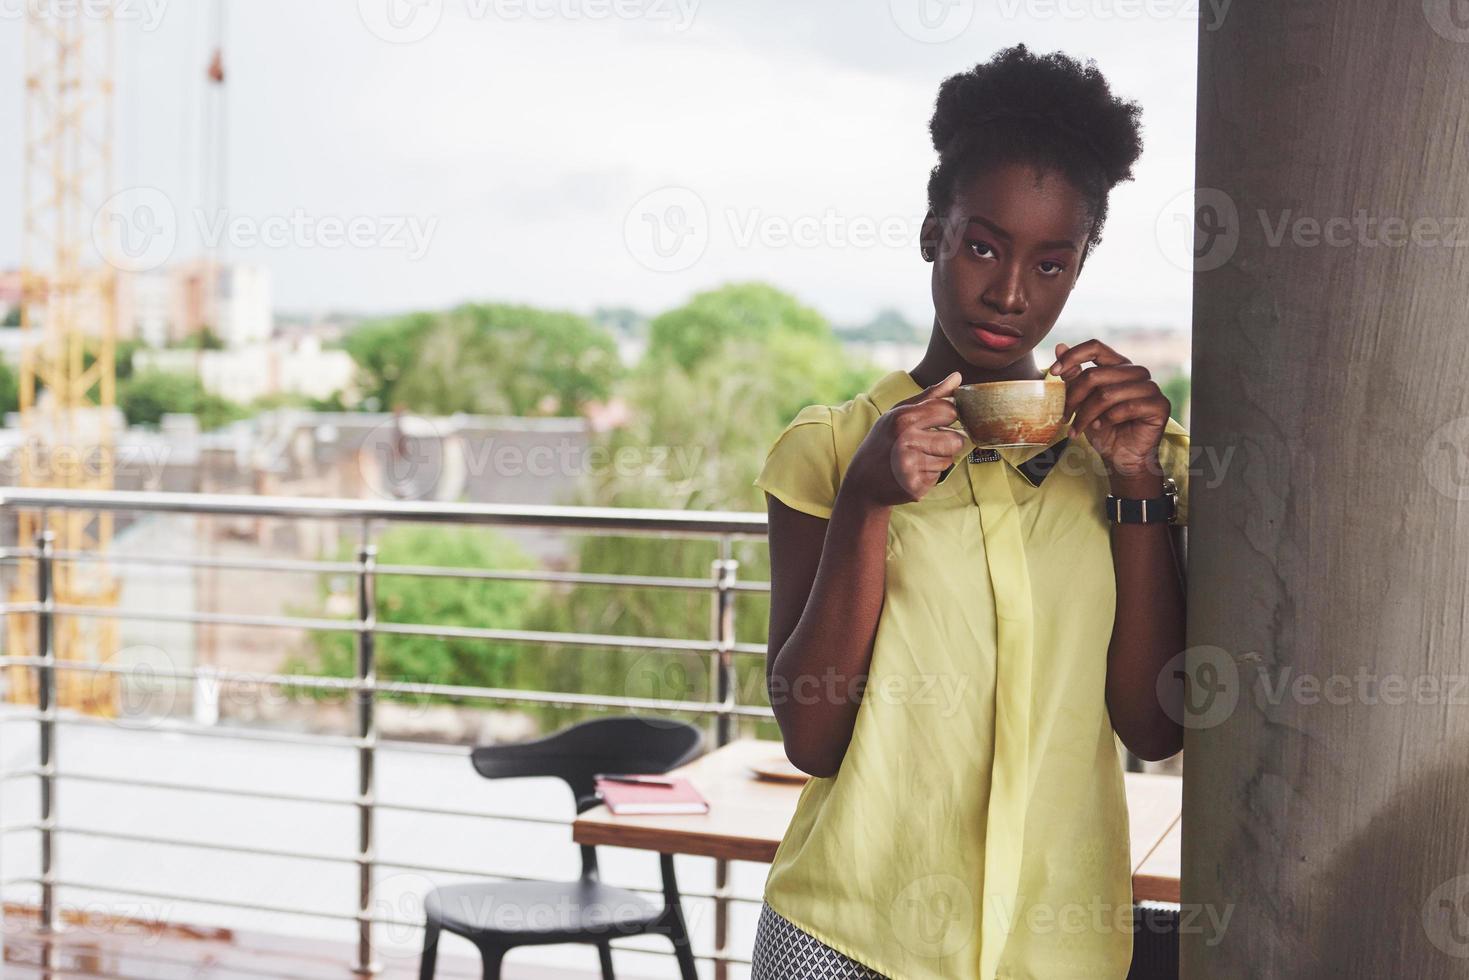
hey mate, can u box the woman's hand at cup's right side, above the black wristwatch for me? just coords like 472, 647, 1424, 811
1050, 339, 1172, 478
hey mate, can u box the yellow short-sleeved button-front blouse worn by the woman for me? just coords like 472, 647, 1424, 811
755, 370, 1188, 980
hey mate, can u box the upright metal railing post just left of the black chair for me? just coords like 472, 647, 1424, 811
354, 540, 382, 974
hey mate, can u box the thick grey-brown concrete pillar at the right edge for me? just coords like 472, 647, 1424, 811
1181, 0, 1469, 980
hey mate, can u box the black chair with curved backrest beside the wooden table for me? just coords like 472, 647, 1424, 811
419, 716, 704, 980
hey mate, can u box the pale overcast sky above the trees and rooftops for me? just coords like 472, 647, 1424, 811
0, 0, 1192, 328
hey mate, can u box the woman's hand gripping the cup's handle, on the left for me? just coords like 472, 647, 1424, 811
842, 372, 964, 507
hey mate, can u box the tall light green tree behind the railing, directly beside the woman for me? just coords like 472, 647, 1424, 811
532, 284, 877, 736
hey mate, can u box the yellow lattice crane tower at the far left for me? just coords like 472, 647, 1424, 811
6, 0, 119, 717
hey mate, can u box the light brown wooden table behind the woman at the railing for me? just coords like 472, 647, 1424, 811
571, 739, 1183, 902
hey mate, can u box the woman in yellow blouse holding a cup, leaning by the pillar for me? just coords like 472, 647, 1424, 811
752, 46, 1188, 980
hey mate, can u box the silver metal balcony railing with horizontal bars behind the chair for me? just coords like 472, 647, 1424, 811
0, 488, 774, 979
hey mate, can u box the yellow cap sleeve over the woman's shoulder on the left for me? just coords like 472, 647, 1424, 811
755, 394, 880, 519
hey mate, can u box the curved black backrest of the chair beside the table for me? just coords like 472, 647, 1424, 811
470, 714, 704, 813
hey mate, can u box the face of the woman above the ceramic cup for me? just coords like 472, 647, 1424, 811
923, 165, 1091, 370
